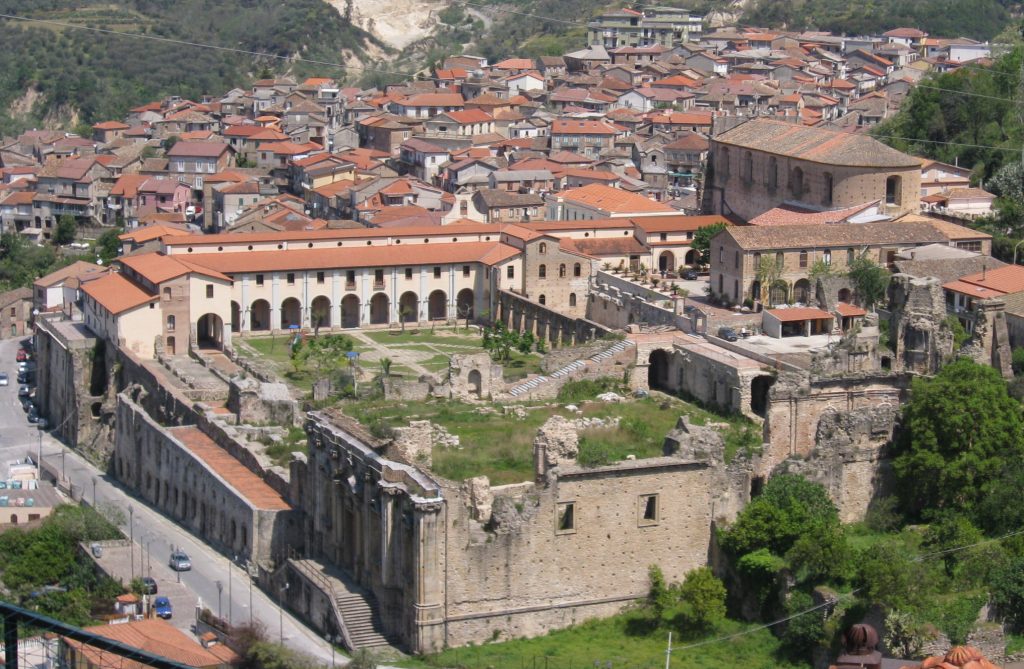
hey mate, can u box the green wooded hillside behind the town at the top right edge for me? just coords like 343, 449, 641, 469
743, 0, 1017, 40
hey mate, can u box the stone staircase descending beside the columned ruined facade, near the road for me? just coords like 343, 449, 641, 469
289, 558, 394, 651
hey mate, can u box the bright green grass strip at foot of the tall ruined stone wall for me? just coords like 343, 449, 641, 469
399, 606, 811, 669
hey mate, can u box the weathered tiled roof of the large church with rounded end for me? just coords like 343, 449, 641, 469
715, 119, 921, 168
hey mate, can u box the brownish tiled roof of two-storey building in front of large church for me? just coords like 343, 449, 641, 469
721, 221, 948, 251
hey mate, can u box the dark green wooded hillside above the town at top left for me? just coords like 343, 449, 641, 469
0, 0, 380, 134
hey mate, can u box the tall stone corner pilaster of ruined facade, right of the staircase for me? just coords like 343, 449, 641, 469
412, 500, 446, 653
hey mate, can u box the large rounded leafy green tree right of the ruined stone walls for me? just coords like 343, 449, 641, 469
893, 359, 1024, 516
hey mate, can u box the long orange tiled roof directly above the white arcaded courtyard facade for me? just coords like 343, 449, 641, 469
181, 239, 519, 274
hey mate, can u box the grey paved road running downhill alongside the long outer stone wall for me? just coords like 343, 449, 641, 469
0, 340, 341, 664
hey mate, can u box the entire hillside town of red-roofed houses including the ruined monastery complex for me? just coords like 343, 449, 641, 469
0, 6, 1024, 669
